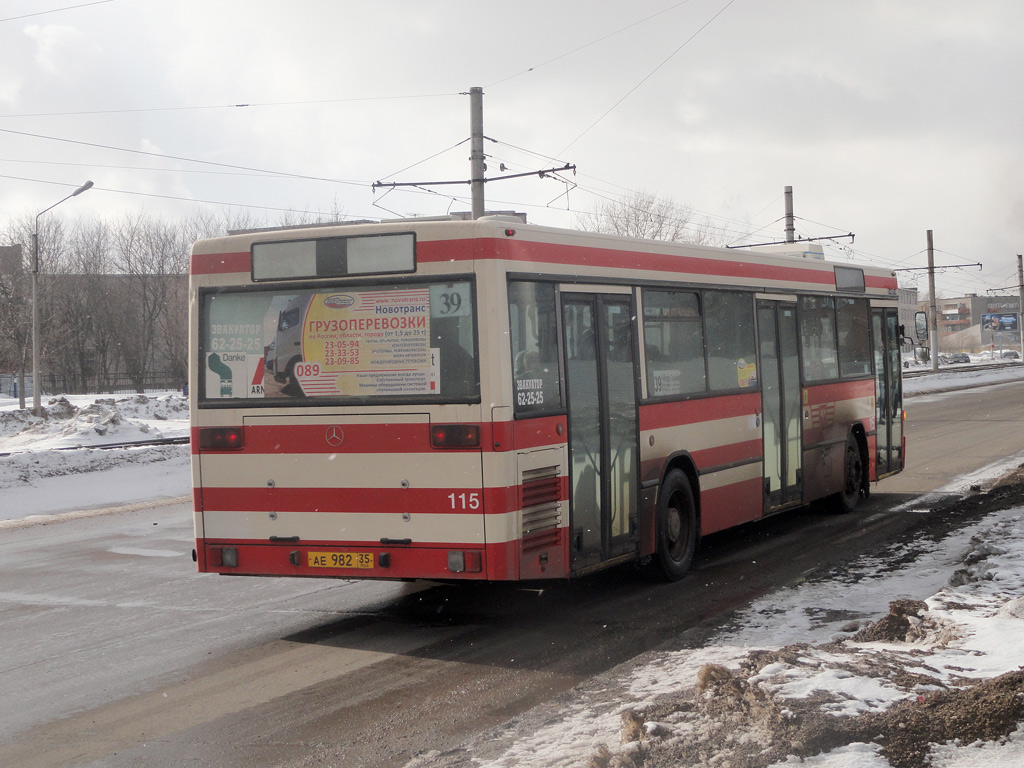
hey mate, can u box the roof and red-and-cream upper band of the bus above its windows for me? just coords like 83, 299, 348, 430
191, 216, 897, 297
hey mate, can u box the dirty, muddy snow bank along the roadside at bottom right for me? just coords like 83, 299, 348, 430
410, 492, 1024, 768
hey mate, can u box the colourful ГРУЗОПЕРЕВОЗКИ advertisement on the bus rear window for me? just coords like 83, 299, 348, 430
206, 286, 444, 398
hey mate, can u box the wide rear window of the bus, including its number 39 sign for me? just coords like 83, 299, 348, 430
200, 281, 479, 404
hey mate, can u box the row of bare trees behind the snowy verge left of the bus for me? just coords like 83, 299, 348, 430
0, 208, 195, 392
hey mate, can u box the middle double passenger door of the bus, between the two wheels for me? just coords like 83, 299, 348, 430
758, 300, 803, 513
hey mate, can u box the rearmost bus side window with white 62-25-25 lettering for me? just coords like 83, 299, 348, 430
509, 281, 562, 415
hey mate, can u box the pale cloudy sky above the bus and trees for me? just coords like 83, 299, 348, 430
0, 0, 1024, 297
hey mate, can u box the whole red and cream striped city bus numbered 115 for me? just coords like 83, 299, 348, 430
189, 217, 904, 581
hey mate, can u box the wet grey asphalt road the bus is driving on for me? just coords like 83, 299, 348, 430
0, 384, 1024, 768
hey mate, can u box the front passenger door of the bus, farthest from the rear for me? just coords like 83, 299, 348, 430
871, 309, 903, 479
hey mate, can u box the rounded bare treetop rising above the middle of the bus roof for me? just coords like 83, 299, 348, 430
577, 190, 721, 245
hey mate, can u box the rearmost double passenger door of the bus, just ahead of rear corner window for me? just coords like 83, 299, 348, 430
562, 293, 639, 571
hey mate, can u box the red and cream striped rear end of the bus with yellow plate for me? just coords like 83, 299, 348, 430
189, 225, 509, 580
